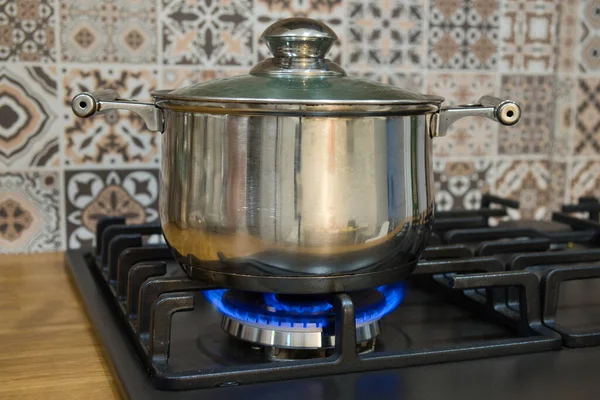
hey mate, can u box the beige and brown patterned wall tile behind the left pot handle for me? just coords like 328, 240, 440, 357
62, 68, 160, 165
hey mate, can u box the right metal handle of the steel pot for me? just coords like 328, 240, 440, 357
431, 96, 521, 137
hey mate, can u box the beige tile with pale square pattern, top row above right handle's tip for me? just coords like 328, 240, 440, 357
500, 0, 558, 72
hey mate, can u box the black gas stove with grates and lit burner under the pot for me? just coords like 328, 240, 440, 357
66, 195, 600, 399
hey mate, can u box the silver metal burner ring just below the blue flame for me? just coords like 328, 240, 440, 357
221, 315, 381, 349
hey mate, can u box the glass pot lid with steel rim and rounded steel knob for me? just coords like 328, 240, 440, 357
153, 18, 444, 105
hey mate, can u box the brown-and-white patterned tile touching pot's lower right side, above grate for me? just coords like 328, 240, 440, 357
433, 158, 493, 211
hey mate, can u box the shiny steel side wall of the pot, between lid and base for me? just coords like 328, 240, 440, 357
161, 109, 433, 282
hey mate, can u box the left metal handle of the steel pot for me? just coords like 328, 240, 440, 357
71, 89, 163, 132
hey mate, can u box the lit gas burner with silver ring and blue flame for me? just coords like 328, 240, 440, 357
204, 284, 404, 359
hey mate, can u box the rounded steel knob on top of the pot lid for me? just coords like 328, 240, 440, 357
261, 18, 337, 59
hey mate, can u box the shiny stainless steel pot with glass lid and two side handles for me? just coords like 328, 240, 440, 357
73, 18, 520, 293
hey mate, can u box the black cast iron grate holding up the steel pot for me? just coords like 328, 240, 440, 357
64, 198, 580, 390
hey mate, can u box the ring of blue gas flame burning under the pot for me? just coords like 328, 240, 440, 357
204, 283, 405, 328
